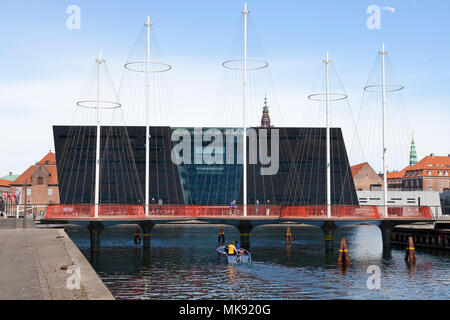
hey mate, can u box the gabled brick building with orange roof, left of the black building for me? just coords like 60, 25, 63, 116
10, 152, 59, 212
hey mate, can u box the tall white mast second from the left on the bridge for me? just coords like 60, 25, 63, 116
145, 17, 152, 216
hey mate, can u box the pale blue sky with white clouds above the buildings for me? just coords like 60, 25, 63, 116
0, 0, 450, 175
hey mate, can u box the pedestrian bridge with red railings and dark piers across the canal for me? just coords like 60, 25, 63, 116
44, 204, 433, 250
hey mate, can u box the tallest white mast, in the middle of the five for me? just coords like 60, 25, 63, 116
242, 3, 250, 216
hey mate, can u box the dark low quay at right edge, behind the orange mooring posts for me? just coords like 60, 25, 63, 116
391, 222, 450, 250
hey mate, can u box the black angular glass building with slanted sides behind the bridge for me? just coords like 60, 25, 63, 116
53, 126, 358, 205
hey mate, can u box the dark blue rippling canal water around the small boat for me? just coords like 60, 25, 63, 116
65, 224, 450, 300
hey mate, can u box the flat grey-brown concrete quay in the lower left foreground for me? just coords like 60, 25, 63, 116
0, 228, 114, 300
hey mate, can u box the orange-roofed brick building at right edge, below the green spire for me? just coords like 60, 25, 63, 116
387, 154, 450, 193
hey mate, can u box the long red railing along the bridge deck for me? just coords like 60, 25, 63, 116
45, 204, 433, 220
